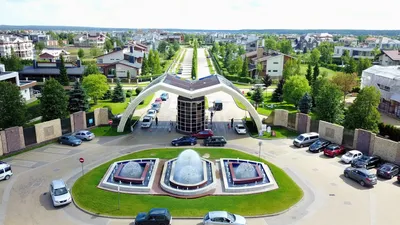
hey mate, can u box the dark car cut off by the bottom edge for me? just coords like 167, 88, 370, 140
135, 208, 172, 225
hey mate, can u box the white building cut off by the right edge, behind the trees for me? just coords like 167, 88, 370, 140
361, 66, 400, 118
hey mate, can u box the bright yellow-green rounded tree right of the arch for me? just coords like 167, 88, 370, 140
283, 75, 311, 108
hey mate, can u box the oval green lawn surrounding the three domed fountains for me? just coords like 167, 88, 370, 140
72, 148, 303, 217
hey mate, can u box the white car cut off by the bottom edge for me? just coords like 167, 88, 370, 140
203, 211, 246, 225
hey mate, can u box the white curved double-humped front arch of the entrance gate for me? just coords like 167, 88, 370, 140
118, 78, 262, 132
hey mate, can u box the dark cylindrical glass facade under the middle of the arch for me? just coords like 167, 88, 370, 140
176, 96, 205, 133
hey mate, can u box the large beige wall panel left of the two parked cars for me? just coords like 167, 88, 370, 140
35, 119, 62, 143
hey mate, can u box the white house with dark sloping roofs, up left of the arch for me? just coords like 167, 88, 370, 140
96, 43, 148, 78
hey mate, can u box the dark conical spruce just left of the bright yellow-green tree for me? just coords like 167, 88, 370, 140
68, 80, 89, 113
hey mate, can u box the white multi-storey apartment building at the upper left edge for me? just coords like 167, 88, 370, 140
0, 35, 33, 60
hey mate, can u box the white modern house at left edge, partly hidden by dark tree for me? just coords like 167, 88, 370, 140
0, 64, 36, 101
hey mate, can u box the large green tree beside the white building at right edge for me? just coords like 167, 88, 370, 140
344, 86, 381, 132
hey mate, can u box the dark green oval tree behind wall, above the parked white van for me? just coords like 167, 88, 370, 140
315, 82, 344, 124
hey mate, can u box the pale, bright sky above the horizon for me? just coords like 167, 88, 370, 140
0, 0, 400, 30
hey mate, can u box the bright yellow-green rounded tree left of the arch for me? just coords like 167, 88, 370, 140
82, 74, 109, 104
